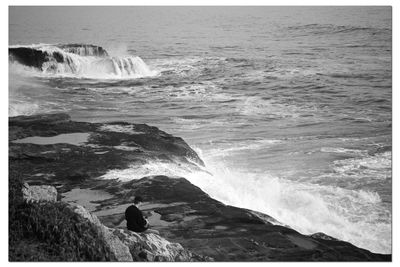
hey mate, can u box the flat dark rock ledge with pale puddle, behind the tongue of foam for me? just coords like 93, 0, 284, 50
9, 114, 204, 193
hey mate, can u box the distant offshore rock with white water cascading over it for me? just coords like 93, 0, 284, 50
8, 44, 158, 79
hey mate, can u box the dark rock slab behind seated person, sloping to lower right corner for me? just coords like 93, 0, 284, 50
90, 176, 387, 261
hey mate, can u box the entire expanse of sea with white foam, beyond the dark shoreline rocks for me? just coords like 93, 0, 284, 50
9, 7, 392, 253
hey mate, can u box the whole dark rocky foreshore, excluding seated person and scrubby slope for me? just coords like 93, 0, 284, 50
9, 114, 391, 261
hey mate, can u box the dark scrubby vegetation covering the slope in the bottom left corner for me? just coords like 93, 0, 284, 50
9, 171, 114, 261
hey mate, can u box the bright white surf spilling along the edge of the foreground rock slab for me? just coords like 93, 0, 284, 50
98, 148, 391, 253
